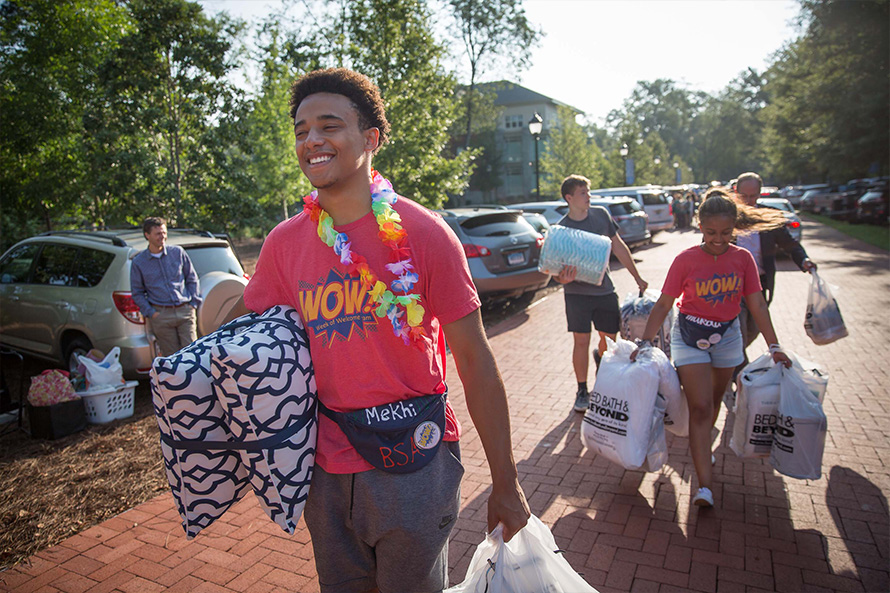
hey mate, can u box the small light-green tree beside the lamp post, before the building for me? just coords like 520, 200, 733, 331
540, 105, 603, 196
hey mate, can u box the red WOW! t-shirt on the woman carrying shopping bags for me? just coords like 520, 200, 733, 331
661, 245, 760, 321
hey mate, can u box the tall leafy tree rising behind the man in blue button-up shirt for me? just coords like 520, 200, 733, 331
96, 0, 243, 224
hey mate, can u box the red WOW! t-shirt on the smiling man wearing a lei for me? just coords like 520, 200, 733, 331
244, 197, 480, 473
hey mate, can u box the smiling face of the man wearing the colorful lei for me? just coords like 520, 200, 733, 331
294, 93, 379, 190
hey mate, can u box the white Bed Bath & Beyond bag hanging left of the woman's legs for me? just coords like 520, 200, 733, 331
581, 338, 664, 471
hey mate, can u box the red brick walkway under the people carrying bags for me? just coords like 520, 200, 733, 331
0, 224, 890, 593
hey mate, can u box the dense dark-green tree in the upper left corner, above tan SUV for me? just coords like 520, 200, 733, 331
0, 0, 131, 244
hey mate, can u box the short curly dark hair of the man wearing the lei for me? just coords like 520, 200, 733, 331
290, 68, 389, 153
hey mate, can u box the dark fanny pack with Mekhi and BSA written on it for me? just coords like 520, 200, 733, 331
318, 391, 448, 474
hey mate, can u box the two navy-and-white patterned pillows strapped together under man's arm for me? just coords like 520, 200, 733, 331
151, 306, 317, 539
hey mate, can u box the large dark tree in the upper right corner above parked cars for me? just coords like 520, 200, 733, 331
763, 0, 890, 181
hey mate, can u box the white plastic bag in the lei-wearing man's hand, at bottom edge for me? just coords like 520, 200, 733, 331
444, 515, 597, 593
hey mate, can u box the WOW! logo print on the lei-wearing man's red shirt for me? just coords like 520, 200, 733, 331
299, 270, 377, 346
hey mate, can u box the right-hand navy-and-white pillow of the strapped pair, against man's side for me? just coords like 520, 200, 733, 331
211, 307, 317, 534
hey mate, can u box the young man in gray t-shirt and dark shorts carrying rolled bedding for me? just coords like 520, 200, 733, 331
556, 175, 649, 412
